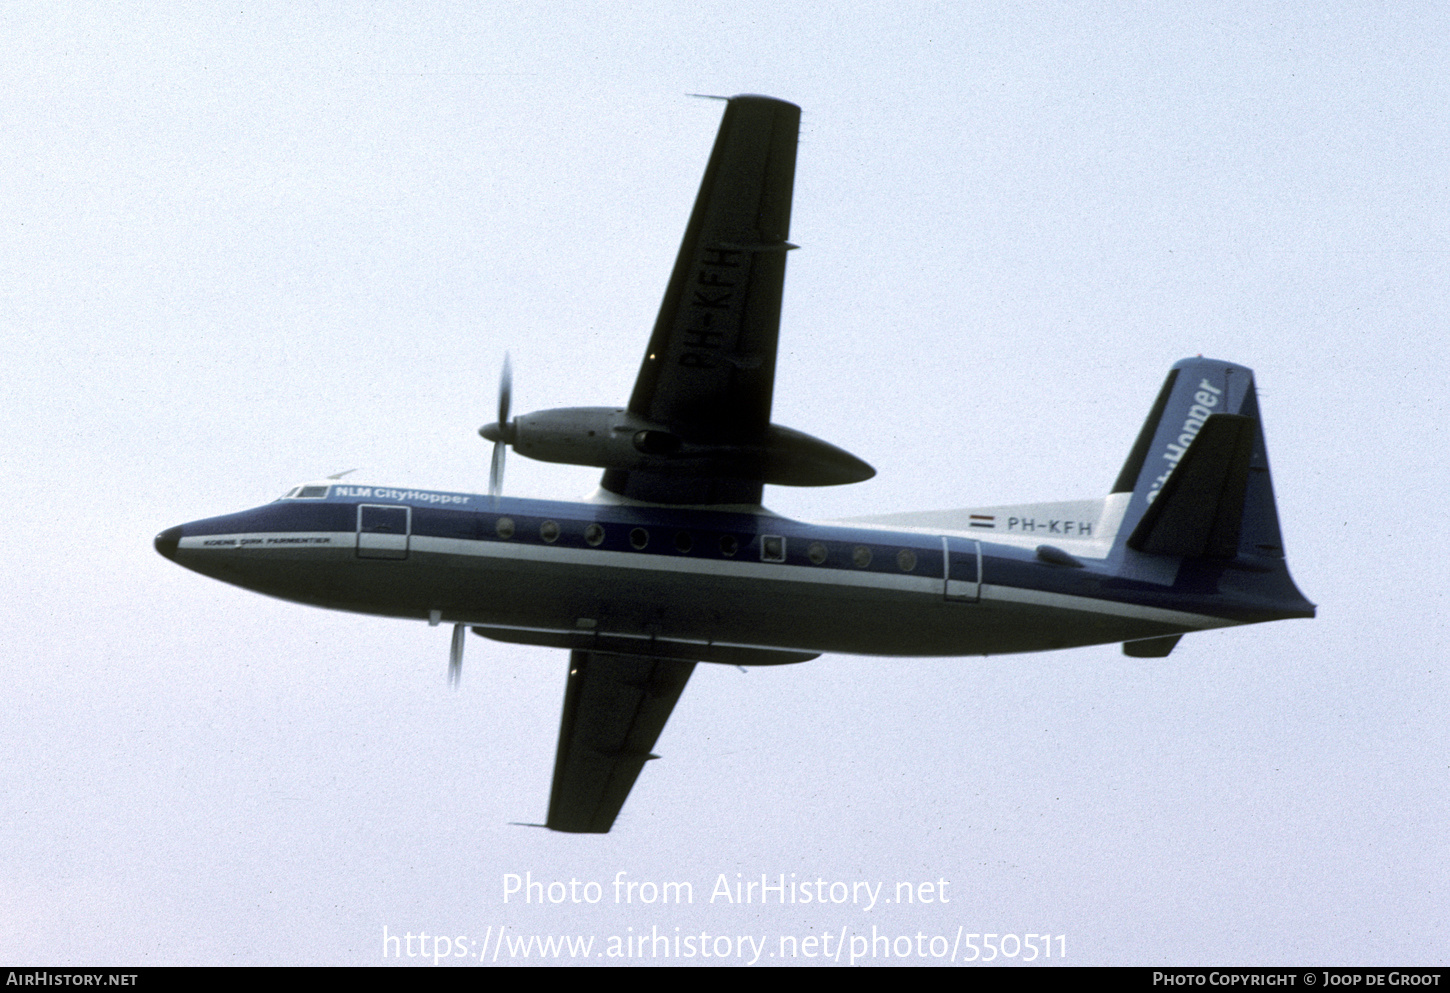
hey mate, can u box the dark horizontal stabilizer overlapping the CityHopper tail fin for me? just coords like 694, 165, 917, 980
1128, 413, 1257, 558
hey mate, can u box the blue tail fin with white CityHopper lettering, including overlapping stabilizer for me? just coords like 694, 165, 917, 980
1114, 358, 1283, 561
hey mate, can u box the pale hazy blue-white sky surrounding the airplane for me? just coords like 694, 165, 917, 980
0, 1, 1450, 965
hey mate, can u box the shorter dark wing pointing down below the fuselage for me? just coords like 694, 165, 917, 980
545, 651, 695, 834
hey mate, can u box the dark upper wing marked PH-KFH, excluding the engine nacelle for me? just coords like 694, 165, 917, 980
603, 96, 800, 503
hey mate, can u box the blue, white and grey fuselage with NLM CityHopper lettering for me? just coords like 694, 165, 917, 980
155, 484, 1312, 664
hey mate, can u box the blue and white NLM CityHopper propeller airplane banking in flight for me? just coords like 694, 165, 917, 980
155, 96, 1315, 834
